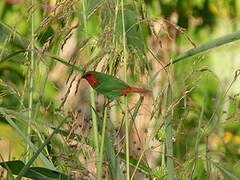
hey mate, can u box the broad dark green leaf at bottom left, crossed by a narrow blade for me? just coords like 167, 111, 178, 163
0, 160, 73, 180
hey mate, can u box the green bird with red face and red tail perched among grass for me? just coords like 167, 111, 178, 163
81, 71, 151, 100
